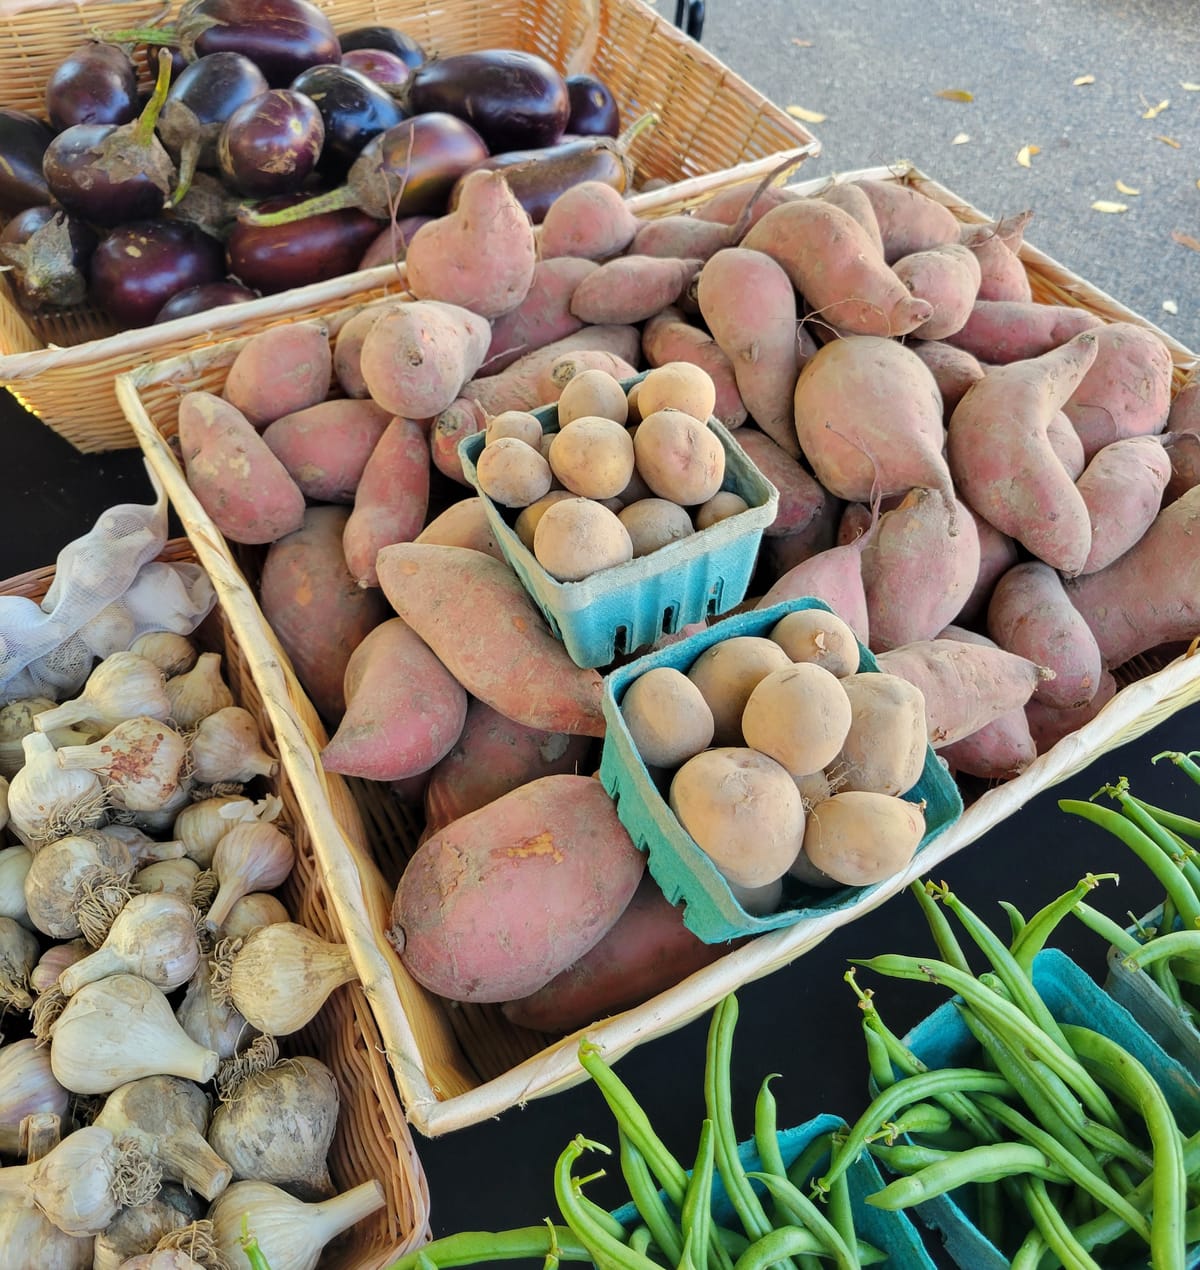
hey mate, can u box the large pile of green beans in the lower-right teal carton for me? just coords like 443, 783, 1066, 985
833, 873, 1200, 1270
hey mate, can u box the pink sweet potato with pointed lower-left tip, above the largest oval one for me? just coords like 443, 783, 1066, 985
321, 617, 467, 781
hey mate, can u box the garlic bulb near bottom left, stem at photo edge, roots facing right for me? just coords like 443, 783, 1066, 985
0, 1125, 160, 1234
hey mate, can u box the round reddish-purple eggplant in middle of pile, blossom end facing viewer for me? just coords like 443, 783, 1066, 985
217, 88, 325, 198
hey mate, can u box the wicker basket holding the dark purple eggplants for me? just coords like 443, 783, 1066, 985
0, 0, 820, 452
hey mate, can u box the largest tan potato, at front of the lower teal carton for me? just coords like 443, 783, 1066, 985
668, 745, 804, 886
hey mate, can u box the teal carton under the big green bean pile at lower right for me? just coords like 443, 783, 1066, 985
904, 949, 1200, 1270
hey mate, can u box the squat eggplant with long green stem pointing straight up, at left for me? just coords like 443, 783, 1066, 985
42, 51, 175, 225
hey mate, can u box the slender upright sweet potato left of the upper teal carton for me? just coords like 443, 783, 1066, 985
342, 417, 429, 587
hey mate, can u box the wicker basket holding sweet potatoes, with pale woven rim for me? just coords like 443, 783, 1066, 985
117, 161, 1200, 1135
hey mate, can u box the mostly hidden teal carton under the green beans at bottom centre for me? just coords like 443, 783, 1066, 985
612, 1115, 937, 1270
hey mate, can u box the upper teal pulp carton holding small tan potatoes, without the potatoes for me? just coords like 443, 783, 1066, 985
458, 375, 780, 668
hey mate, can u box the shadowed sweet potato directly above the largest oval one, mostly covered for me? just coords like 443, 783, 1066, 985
425, 699, 593, 833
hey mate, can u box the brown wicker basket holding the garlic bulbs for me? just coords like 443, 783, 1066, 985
0, 540, 429, 1270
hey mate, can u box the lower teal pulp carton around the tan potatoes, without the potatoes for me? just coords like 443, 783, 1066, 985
599, 597, 963, 944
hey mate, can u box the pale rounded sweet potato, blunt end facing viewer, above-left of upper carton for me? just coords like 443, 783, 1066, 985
359, 300, 491, 419
